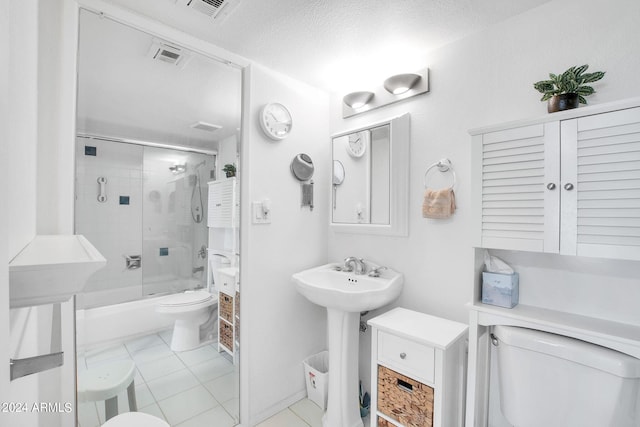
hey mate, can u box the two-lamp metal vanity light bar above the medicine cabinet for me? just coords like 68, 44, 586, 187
342, 68, 429, 119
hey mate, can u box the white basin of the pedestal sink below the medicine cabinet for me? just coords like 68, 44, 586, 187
293, 264, 403, 313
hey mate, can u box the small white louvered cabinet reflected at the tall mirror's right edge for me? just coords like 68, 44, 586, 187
207, 178, 239, 228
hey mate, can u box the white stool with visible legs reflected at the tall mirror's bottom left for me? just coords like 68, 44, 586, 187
78, 360, 138, 425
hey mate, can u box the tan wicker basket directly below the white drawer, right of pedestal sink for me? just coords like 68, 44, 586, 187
378, 365, 433, 427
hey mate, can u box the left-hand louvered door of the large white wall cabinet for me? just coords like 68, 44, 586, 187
473, 122, 560, 253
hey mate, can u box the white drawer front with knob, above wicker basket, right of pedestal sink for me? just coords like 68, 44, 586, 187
378, 331, 435, 384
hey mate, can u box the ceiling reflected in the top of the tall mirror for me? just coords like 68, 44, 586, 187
77, 11, 241, 148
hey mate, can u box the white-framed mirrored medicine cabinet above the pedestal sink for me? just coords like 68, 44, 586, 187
331, 114, 409, 236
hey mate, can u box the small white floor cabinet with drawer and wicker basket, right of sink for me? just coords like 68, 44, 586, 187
368, 308, 467, 427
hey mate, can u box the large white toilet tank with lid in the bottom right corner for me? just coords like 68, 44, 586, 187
493, 326, 640, 427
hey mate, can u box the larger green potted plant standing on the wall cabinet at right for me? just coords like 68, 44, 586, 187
533, 64, 604, 113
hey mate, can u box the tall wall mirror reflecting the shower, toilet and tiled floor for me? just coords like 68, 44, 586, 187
74, 9, 240, 427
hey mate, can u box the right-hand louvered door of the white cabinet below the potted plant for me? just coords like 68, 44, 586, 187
560, 108, 640, 260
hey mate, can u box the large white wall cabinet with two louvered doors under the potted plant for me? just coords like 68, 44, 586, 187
472, 103, 640, 260
